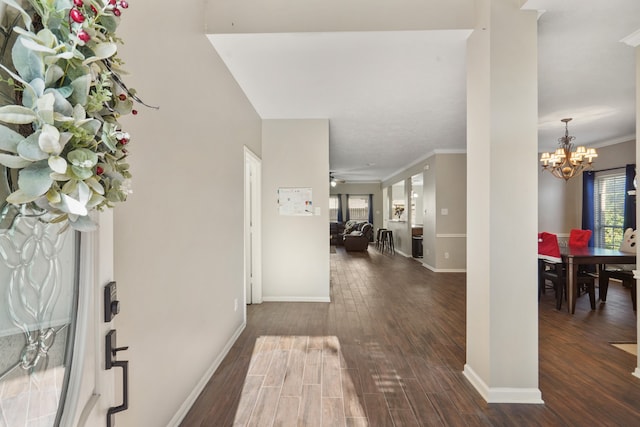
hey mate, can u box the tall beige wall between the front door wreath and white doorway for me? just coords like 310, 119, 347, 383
113, 0, 261, 427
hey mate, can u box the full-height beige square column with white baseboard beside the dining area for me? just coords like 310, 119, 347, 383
464, 0, 543, 403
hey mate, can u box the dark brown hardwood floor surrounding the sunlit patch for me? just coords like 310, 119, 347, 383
182, 246, 640, 427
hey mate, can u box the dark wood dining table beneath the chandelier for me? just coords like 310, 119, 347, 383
560, 246, 636, 314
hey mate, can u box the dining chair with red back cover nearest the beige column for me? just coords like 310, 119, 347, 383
538, 232, 596, 310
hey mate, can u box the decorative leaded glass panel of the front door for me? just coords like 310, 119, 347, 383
0, 207, 80, 427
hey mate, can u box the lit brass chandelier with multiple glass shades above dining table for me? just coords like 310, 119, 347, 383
540, 119, 598, 181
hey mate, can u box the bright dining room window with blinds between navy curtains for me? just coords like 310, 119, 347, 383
594, 173, 625, 249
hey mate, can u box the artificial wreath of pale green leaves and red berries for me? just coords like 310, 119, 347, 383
0, 0, 152, 231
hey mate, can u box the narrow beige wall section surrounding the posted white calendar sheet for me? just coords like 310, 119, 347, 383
262, 119, 329, 301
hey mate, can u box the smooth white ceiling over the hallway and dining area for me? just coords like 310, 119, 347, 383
209, 0, 640, 182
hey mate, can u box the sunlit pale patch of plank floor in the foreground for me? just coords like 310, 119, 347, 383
234, 336, 368, 427
